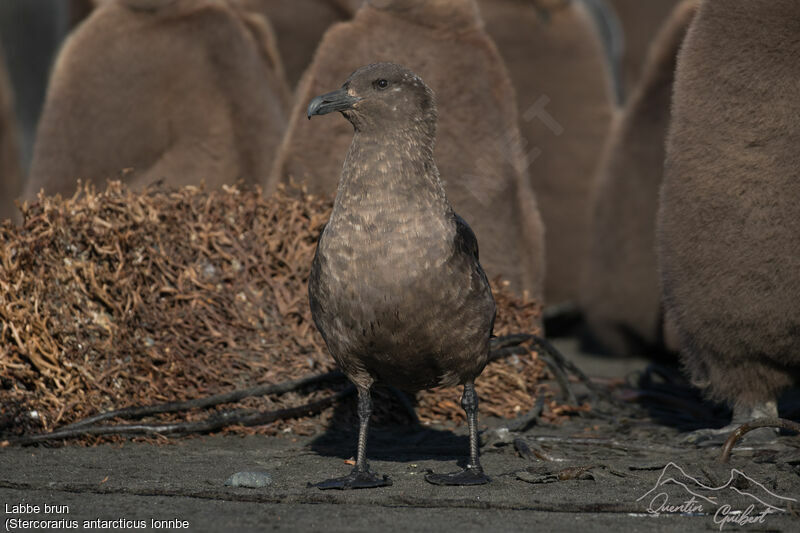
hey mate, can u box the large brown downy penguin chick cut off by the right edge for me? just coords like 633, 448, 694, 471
657, 0, 800, 436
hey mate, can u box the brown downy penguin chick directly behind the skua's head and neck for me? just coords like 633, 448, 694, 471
265, 0, 544, 298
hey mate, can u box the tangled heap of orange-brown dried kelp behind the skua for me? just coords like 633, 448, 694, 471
0, 182, 558, 436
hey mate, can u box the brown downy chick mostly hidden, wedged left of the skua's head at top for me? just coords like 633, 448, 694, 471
236, 0, 358, 87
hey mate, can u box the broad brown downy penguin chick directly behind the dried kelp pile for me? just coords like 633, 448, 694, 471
26, 0, 289, 198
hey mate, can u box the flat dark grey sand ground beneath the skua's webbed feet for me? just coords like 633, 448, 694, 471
0, 338, 800, 532
